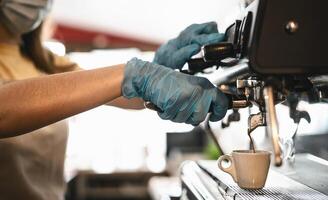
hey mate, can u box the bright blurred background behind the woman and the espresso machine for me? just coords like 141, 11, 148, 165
41, 0, 327, 199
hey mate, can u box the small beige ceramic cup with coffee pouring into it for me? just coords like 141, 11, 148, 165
218, 150, 270, 189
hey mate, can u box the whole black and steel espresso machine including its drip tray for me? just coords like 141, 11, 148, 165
181, 0, 328, 200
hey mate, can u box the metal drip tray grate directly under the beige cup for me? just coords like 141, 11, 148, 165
198, 161, 328, 200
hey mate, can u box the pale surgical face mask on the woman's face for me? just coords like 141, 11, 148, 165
0, 0, 52, 35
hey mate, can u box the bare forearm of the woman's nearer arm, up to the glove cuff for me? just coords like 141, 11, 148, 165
0, 65, 124, 138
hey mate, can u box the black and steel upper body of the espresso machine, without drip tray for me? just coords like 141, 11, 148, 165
189, 0, 328, 166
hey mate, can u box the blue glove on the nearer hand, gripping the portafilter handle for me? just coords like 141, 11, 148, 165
122, 58, 228, 125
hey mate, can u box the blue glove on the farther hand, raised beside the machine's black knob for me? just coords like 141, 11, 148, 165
153, 22, 224, 69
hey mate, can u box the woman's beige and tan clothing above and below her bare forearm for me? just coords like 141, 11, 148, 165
0, 44, 75, 200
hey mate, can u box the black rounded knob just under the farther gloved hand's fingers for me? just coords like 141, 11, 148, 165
202, 42, 235, 62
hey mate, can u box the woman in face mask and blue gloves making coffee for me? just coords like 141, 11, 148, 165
0, 0, 227, 200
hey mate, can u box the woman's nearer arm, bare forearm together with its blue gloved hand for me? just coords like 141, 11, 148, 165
0, 58, 229, 138
